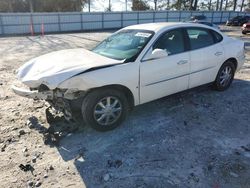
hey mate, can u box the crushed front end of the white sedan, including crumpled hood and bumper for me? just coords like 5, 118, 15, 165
12, 48, 122, 119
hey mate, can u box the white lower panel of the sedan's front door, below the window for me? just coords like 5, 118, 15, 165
140, 52, 190, 103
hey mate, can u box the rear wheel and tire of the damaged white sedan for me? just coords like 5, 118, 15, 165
214, 61, 236, 91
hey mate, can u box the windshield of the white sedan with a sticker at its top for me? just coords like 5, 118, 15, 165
92, 30, 154, 60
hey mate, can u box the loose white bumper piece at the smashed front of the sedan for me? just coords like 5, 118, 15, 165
11, 85, 54, 100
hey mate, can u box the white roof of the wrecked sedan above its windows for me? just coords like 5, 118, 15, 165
124, 22, 215, 32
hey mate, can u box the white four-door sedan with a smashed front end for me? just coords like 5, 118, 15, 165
12, 23, 245, 131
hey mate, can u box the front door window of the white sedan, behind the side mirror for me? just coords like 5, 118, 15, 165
153, 30, 185, 55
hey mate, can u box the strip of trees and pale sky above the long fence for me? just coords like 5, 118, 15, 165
0, 0, 250, 12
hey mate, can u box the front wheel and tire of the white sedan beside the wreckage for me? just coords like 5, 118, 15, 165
81, 89, 129, 132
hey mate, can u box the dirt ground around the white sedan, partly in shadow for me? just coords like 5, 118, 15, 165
0, 27, 250, 188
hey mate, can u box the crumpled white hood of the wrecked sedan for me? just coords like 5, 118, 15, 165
17, 48, 123, 89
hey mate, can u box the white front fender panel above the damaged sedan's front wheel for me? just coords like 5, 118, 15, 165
58, 62, 140, 105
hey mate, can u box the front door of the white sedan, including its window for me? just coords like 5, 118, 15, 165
140, 29, 190, 103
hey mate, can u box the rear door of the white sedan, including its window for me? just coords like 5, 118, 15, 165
186, 27, 224, 88
